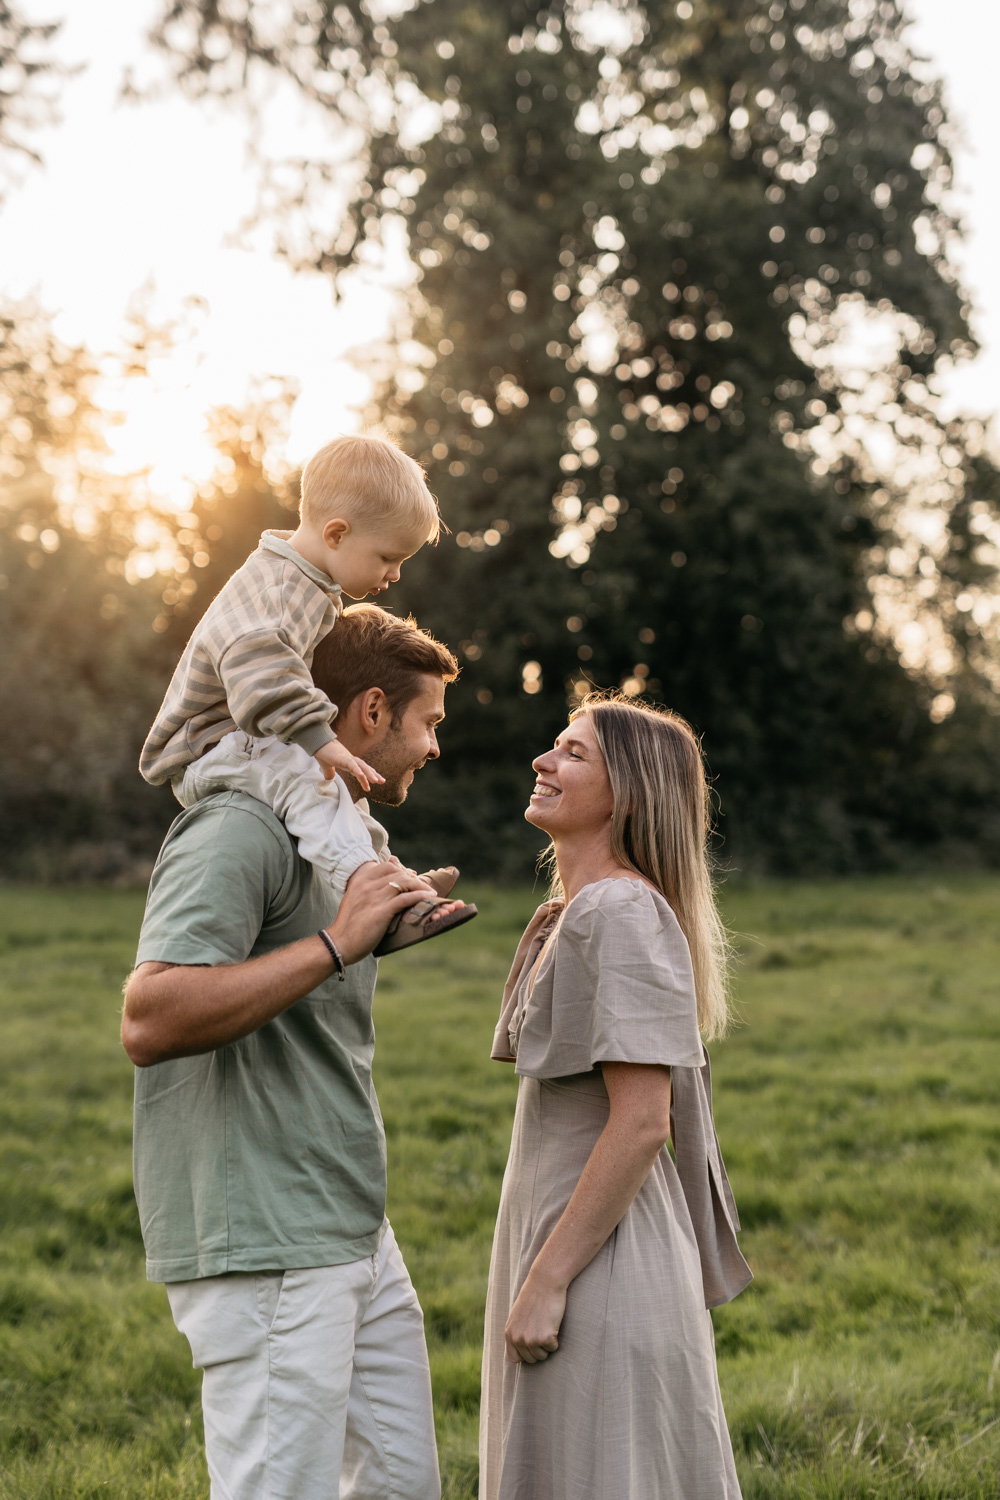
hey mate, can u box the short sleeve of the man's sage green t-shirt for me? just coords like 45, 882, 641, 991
136, 792, 294, 965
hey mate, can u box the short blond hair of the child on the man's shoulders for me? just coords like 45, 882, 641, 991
298, 434, 441, 542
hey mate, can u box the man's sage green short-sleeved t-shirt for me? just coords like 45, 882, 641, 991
135, 792, 385, 1281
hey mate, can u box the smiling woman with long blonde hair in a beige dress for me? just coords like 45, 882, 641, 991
480, 695, 751, 1500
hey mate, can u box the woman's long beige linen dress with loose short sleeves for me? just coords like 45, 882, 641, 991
480, 879, 750, 1500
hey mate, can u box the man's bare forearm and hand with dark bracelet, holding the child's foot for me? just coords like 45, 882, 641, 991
121, 861, 433, 1068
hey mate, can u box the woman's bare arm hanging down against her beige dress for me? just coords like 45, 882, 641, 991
505, 1062, 670, 1365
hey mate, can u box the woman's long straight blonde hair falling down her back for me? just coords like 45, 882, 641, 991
554, 692, 730, 1041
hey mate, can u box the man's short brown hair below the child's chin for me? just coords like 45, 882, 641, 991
312, 605, 459, 725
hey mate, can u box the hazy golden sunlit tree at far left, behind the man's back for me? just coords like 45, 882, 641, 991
0, 308, 182, 878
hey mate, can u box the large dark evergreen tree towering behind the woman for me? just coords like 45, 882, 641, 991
150, 0, 996, 867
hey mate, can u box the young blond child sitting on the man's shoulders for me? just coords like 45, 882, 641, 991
139, 437, 475, 954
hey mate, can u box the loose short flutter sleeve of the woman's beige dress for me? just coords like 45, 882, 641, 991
516, 878, 703, 1079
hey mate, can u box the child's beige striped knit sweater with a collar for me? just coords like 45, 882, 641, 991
139, 531, 343, 786
